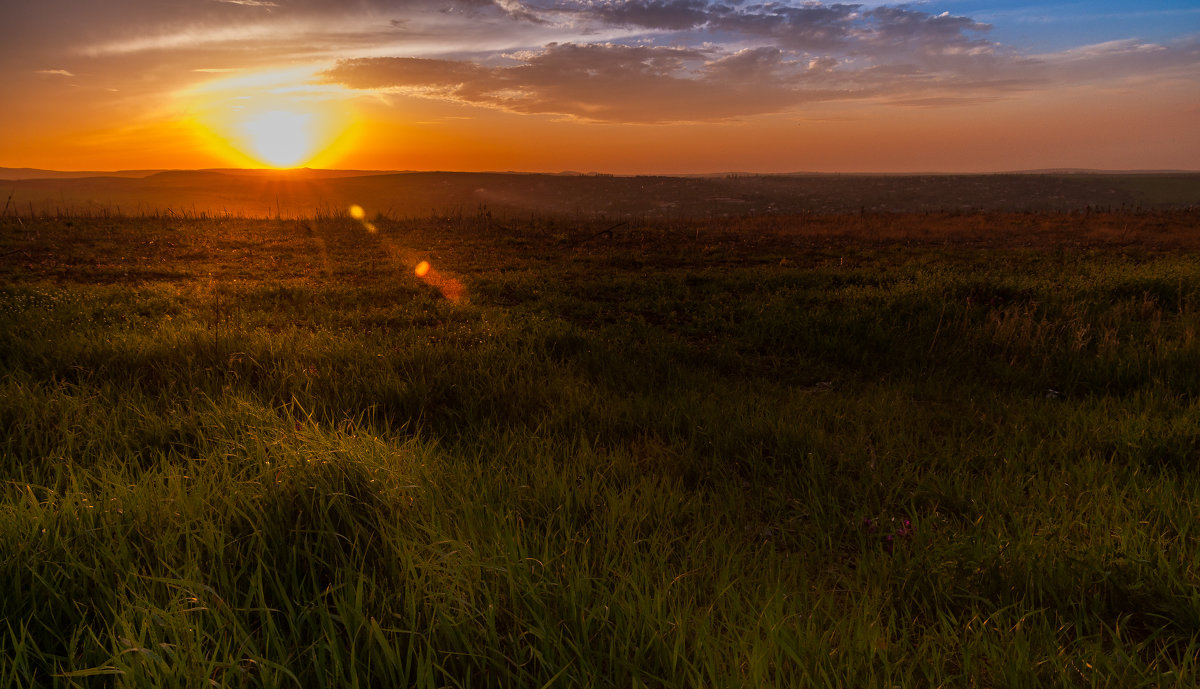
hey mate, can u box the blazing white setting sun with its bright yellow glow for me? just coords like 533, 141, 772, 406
181, 70, 355, 168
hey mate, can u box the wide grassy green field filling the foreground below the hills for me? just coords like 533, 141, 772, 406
0, 206, 1200, 688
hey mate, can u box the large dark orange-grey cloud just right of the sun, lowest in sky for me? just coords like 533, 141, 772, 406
324, 43, 878, 122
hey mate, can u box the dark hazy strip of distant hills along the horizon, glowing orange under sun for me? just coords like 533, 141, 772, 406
0, 169, 1200, 217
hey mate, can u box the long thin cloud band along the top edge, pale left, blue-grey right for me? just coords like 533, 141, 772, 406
77, 0, 995, 65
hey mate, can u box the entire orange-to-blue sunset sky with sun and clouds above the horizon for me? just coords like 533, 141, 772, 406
0, 0, 1200, 174
